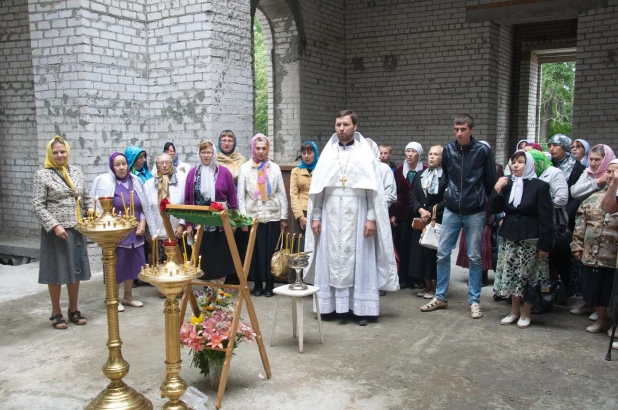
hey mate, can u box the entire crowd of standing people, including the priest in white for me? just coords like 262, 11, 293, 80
33, 111, 618, 352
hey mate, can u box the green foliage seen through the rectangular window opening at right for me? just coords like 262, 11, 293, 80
539, 61, 575, 141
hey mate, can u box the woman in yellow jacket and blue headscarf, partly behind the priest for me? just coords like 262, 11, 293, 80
290, 141, 320, 244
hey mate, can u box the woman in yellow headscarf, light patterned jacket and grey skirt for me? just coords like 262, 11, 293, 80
32, 136, 92, 329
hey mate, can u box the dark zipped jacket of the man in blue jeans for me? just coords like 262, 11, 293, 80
442, 138, 497, 215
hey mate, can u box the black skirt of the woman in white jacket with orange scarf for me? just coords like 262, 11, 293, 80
249, 221, 281, 282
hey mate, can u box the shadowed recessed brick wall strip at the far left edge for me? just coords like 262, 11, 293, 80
0, 0, 40, 234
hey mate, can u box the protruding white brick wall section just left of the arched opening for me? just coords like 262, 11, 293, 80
146, 0, 253, 163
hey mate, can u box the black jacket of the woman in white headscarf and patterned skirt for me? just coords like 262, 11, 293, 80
489, 178, 554, 251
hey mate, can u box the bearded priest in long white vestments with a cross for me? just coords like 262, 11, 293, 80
305, 112, 399, 326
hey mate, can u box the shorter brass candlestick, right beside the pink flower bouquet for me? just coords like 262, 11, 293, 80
138, 240, 202, 410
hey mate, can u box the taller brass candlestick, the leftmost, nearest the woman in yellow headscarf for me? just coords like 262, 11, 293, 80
75, 198, 152, 410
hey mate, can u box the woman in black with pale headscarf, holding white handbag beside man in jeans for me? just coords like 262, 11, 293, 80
410, 145, 446, 299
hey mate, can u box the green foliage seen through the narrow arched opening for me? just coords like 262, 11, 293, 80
253, 18, 268, 135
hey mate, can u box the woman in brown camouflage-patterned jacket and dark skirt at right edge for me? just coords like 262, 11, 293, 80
571, 159, 618, 333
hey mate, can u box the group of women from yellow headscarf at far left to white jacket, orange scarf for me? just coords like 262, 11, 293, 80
32, 130, 288, 329
